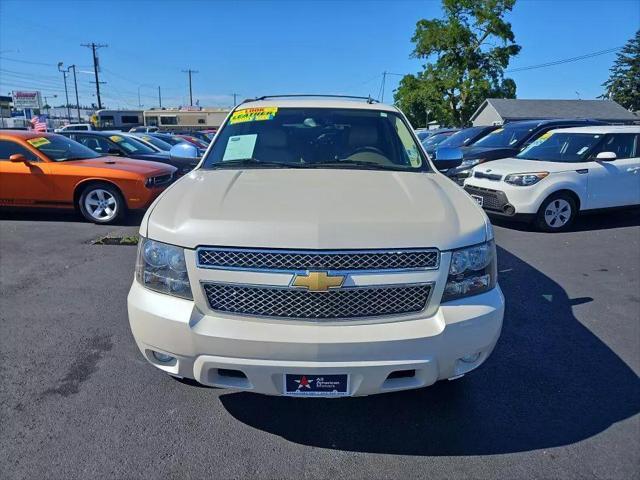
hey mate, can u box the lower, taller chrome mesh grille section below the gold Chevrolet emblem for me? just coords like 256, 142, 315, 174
203, 283, 431, 319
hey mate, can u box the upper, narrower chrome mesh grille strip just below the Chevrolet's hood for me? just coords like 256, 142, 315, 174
198, 247, 440, 270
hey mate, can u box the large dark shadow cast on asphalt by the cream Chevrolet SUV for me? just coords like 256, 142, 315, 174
220, 248, 640, 456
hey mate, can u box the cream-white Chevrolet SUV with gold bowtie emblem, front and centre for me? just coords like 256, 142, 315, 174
128, 96, 504, 397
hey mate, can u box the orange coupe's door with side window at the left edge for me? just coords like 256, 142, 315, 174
0, 139, 54, 205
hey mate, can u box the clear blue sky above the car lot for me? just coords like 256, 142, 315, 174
0, 0, 640, 108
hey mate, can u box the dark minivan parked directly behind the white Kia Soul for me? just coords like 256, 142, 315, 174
434, 119, 604, 183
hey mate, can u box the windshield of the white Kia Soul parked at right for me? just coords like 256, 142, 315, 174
517, 132, 602, 162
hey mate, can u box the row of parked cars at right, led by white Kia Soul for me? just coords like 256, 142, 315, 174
422, 120, 640, 232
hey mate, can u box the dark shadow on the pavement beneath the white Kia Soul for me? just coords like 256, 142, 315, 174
491, 208, 640, 232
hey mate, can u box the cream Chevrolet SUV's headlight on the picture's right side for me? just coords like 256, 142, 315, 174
442, 240, 498, 302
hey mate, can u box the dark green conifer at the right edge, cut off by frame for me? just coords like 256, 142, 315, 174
601, 30, 640, 112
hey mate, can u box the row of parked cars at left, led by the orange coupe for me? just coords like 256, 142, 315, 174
0, 128, 206, 224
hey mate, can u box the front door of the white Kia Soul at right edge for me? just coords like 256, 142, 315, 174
587, 133, 640, 209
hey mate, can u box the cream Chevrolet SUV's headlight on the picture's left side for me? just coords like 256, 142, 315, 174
136, 238, 193, 300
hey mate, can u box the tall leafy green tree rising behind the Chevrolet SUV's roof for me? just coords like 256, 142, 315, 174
394, 0, 520, 126
